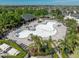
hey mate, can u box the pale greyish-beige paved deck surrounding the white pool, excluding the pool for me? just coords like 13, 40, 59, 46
7, 20, 67, 46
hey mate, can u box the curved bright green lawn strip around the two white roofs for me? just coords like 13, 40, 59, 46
0, 40, 27, 58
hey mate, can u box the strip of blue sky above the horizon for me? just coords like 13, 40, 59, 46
0, 0, 79, 5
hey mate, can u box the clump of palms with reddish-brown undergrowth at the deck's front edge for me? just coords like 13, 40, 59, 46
32, 35, 53, 55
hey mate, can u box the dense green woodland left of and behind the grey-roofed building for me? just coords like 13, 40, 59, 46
0, 7, 48, 38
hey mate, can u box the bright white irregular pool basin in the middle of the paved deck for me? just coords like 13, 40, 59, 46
18, 22, 57, 38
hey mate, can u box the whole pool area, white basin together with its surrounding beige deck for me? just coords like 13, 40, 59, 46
7, 20, 67, 46
